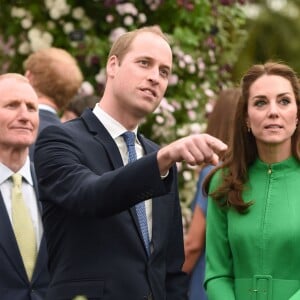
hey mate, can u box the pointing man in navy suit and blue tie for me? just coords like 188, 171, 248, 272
35, 26, 226, 300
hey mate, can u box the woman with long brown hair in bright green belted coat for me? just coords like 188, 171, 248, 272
204, 62, 300, 300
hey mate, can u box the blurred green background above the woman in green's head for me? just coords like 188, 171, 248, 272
232, 0, 300, 81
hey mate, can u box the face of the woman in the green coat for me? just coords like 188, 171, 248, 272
246, 75, 298, 156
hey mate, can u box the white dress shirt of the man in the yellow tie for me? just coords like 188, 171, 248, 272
0, 157, 43, 248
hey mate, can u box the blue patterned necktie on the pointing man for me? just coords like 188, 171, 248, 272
122, 131, 150, 255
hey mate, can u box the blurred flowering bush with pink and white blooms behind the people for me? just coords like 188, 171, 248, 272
0, 0, 247, 229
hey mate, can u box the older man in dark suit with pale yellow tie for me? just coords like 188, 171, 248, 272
0, 73, 49, 300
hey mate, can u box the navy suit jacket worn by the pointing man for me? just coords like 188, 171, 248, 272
35, 110, 187, 300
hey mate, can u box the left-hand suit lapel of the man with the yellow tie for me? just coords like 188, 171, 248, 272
0, 193, 28, 281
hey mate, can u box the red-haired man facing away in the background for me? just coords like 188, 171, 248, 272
24, 47, 83, 160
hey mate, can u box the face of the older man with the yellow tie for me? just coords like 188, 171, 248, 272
0, 77, 39, 150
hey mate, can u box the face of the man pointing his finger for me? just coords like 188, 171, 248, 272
109, 32, 172, 119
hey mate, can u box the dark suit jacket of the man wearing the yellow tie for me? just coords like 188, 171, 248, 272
0, 165, 49, 300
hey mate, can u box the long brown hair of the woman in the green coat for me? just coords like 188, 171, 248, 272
204, 62, 300, 213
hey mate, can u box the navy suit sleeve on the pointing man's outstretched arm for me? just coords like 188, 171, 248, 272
34, 126, 172, 217
